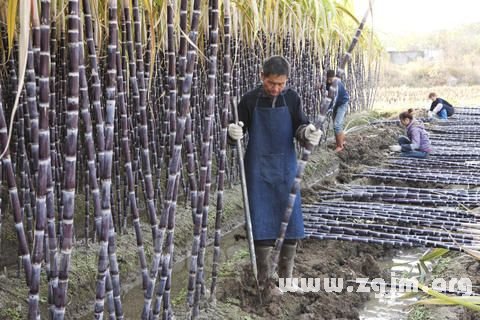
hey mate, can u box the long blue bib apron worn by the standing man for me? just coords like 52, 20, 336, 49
245, 95, 304, 240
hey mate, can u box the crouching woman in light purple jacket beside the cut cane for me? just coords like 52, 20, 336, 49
390, 109, 431, 158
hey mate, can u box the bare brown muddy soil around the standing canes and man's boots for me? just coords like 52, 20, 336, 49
0, 111, 480, 320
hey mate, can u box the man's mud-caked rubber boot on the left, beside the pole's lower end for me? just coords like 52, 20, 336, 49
255, 246, 283, 298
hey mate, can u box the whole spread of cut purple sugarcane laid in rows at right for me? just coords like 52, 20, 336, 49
304, 108, 480, 251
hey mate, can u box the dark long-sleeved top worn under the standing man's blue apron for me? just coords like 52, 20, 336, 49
238, 86, 309, 138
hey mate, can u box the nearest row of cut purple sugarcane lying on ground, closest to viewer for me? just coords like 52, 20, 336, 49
304, 202, 480, 248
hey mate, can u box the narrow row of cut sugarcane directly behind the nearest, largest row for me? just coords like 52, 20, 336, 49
317, 185, 480, 207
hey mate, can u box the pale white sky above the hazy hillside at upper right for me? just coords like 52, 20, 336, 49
354, 0, 480, 36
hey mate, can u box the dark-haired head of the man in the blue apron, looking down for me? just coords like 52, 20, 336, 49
260, 56, 290, 97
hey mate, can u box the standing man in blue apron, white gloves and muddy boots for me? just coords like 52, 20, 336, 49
228, 56, 322, 294
